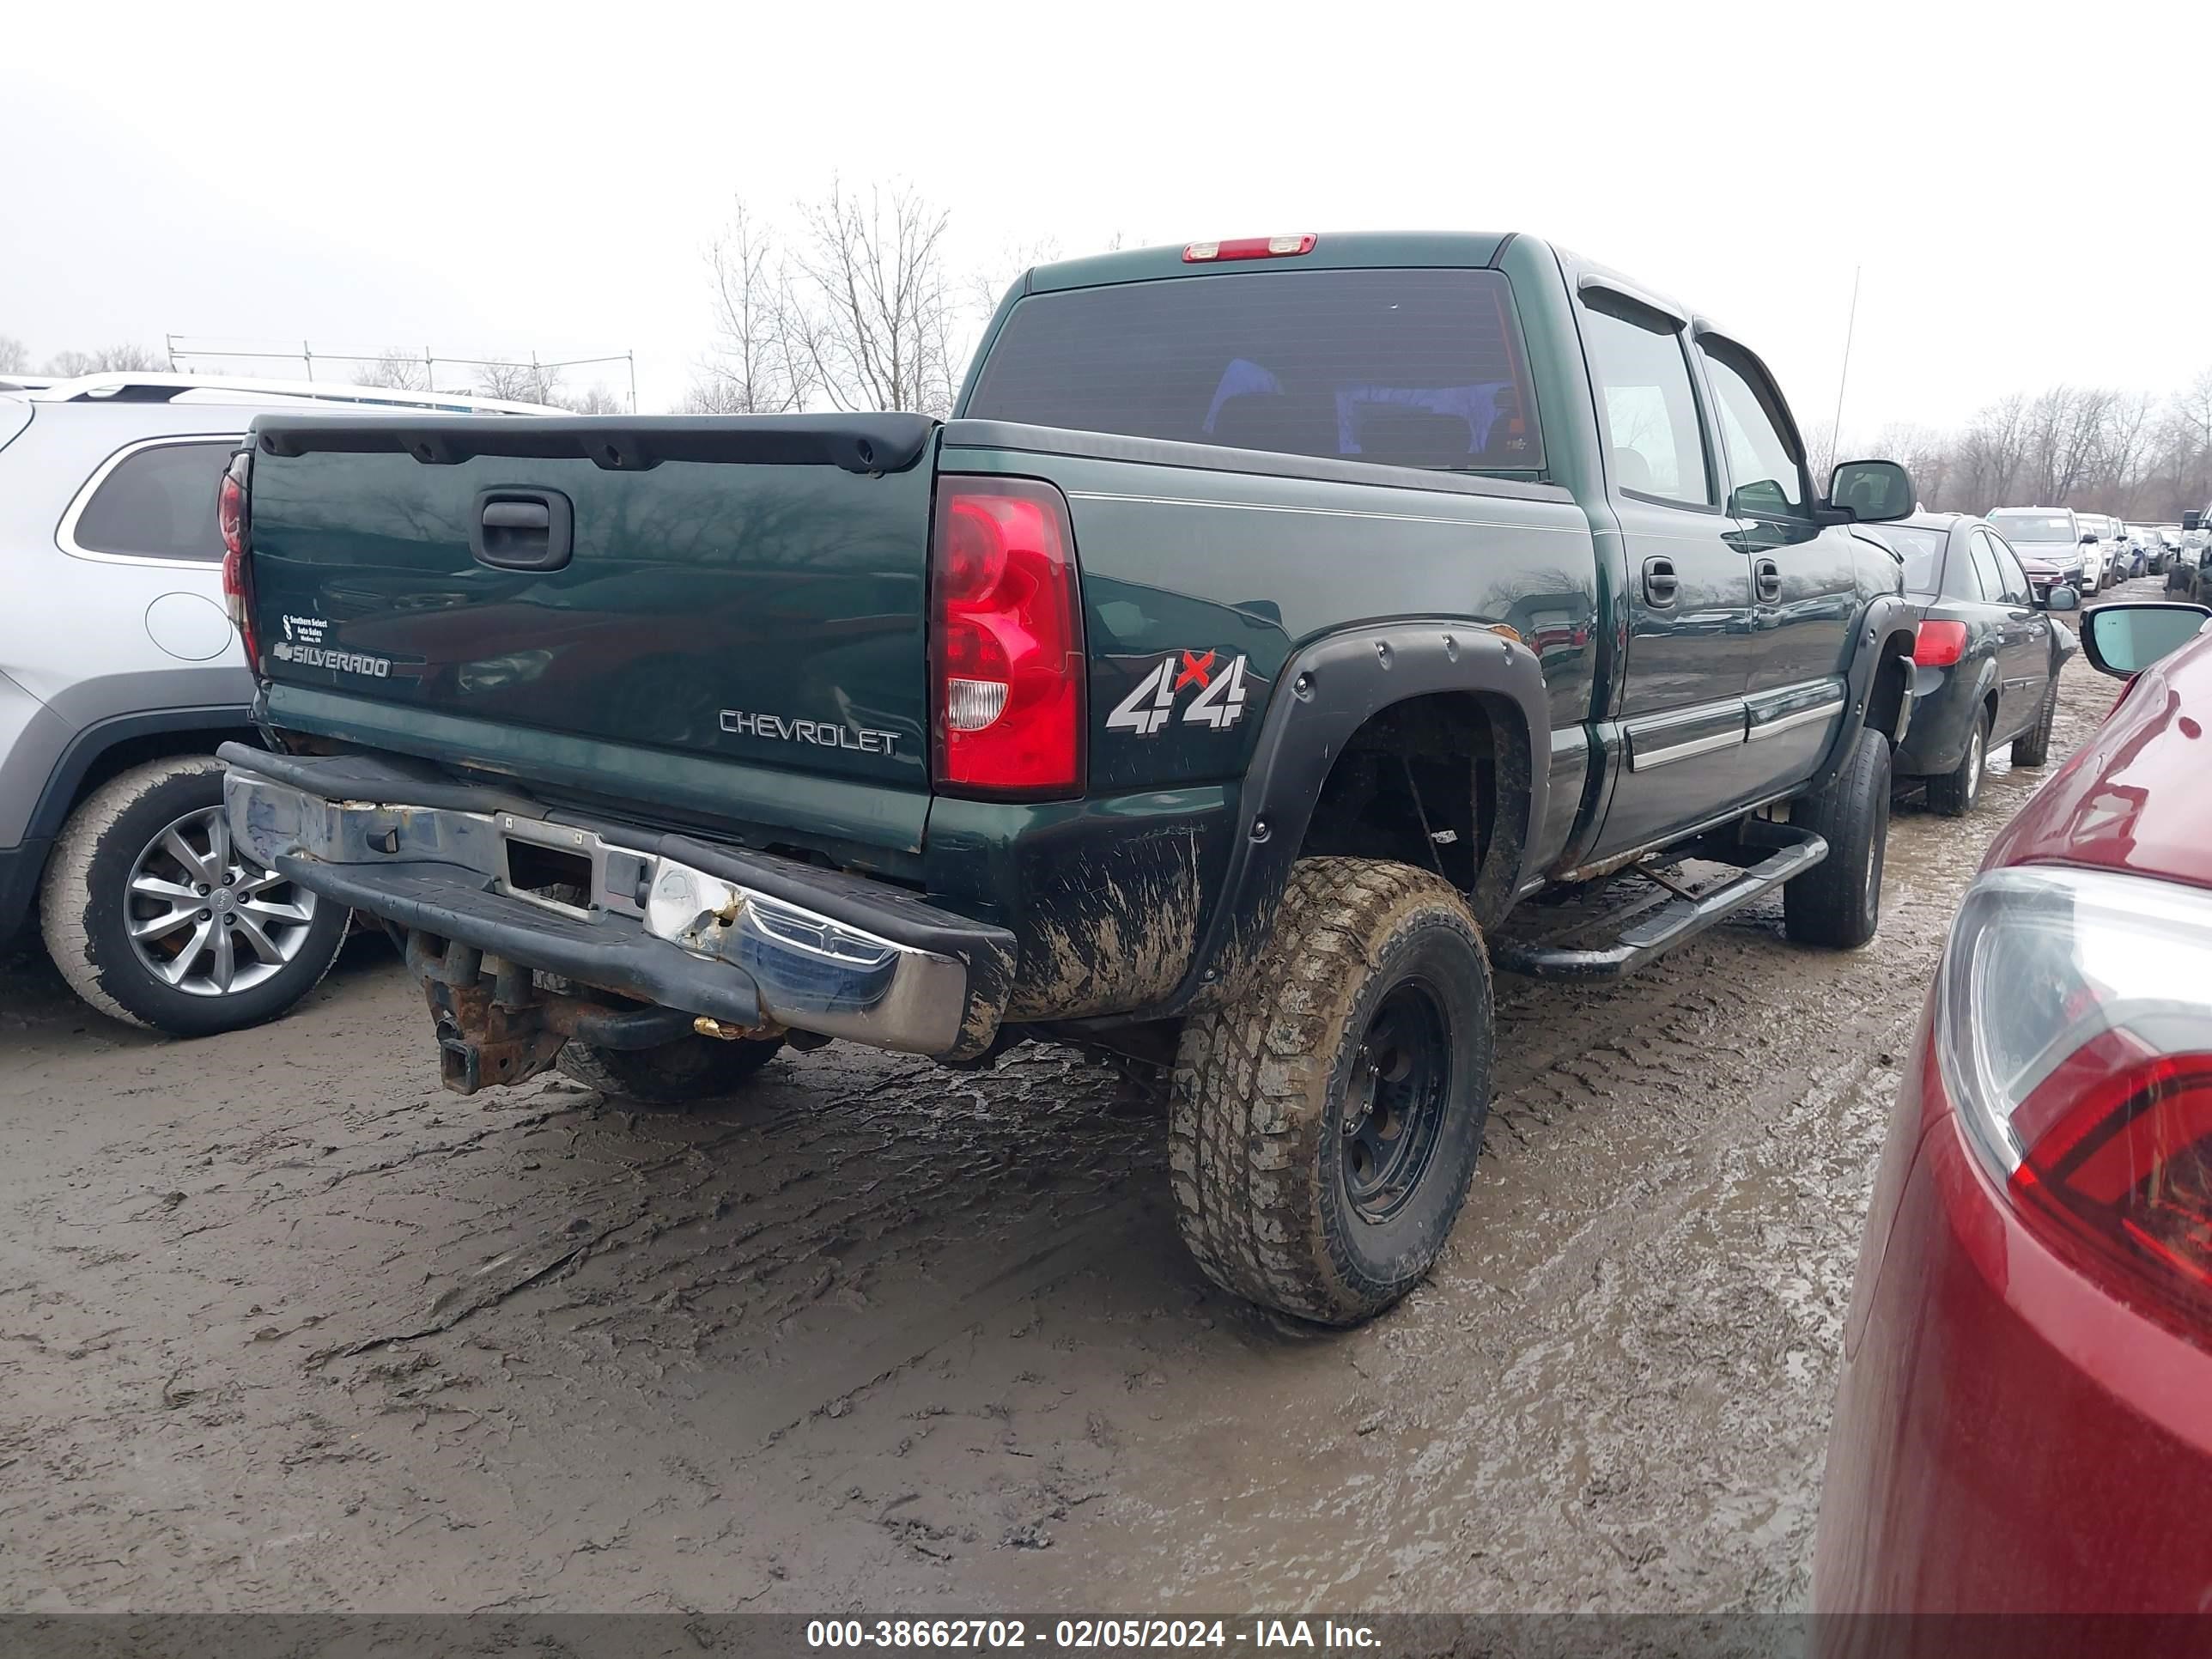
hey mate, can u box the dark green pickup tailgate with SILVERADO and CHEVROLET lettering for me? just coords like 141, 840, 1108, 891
252, 416, 936, 807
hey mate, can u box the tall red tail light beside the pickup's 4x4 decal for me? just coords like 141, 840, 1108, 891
931, 477, 1084, 799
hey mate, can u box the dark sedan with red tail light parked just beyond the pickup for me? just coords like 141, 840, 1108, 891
1860, 514, 2081, 818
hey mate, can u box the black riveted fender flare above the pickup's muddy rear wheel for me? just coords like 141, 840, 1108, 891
1157, 619, 1551, 1015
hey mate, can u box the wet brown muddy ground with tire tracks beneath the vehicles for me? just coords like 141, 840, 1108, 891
0, 584, 2154, 1614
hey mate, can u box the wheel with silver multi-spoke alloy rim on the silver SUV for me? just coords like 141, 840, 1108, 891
40, 754, 349, 1037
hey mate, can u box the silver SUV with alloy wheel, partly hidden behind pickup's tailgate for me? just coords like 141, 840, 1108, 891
0, 374, 557, 1037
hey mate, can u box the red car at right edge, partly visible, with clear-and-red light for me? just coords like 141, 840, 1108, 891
1814, 604, 2212, 1655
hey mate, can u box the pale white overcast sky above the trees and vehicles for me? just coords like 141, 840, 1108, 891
0, 0, 2212, 434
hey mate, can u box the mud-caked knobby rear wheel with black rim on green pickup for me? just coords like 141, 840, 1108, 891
1168, 858, 1493, 1325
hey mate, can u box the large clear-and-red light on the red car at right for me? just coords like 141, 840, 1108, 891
1936, 865, 2212, 1345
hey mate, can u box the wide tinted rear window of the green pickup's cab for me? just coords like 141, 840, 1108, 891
963, 268, 1544, 476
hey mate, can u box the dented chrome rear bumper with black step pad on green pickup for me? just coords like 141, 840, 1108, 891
223, 745, 1013, 1060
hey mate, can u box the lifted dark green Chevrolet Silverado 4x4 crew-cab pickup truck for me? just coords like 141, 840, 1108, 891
222, 234, 1913, 1322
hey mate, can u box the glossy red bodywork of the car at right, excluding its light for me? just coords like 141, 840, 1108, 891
1814, 639, 2212, 1627
